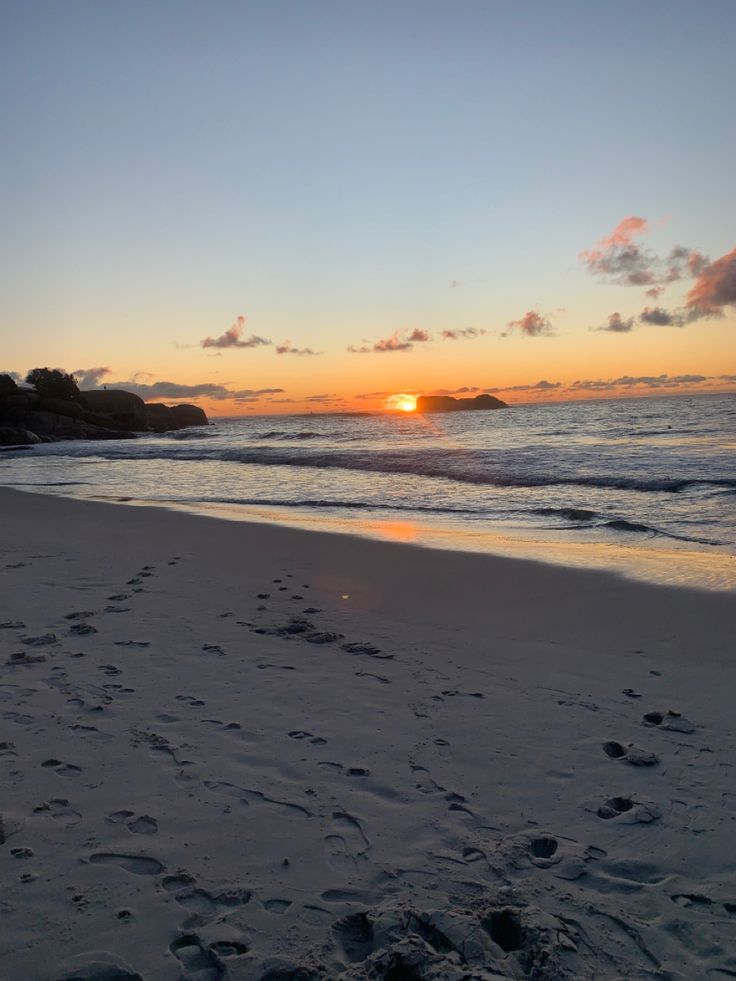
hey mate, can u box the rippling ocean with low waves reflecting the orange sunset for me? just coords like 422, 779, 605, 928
0, 395, 736, 589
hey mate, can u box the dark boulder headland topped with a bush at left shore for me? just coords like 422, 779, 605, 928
0, 368, 208, 446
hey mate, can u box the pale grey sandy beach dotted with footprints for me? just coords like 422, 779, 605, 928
0, 490, 736, 981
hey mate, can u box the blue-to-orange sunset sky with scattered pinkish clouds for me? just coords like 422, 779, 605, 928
0, 0, 736, 415
